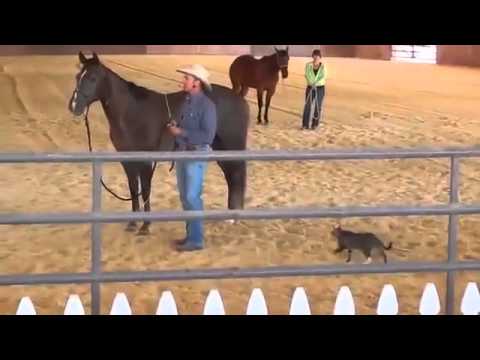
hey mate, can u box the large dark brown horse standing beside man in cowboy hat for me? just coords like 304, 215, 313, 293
69, 52, 250, 235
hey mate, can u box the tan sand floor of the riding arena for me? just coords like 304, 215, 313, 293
0, 56, 480, 314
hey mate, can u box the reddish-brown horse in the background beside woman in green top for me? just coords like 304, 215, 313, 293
230, 46, 290, 125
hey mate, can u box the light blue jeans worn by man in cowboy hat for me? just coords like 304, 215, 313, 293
176, 148, 209, 247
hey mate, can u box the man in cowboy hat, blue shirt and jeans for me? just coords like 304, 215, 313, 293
169, 65, 217, 251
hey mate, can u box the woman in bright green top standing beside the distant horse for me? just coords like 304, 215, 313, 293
302, 49, 327, 130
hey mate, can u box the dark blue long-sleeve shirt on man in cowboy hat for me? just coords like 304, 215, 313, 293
175, 92, 217, 146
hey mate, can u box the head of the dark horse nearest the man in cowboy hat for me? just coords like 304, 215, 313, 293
68, 51, 106, 116
